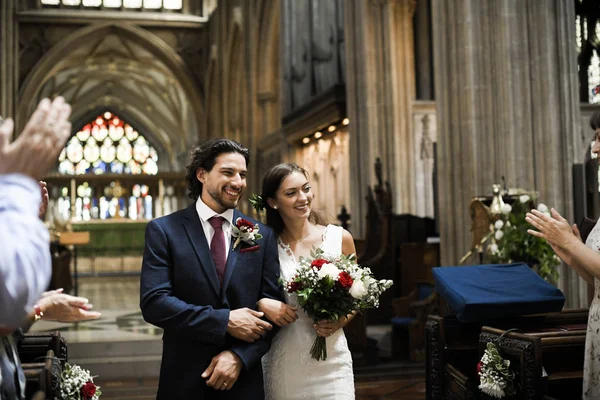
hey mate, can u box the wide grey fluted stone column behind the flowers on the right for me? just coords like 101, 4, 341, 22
432, 0, 579, 306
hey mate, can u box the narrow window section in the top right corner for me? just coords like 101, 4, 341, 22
574, 0, 600, 104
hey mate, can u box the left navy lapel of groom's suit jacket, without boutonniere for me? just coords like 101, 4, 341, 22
183, 203, 221, 298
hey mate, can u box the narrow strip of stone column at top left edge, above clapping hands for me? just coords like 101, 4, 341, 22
0, 0, 18, 123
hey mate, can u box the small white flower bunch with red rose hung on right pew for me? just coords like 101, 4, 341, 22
477, 342, 515, 399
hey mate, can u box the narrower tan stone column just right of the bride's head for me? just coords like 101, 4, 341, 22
344, 0, 416, 237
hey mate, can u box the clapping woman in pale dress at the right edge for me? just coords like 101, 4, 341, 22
525, 112, 600, 400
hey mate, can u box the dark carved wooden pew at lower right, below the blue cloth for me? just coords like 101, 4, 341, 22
425, 309, 588, 400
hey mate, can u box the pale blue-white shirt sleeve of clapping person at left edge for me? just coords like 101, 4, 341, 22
0, 174, 52, 327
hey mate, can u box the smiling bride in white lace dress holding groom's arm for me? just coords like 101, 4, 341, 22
258, 164, 356, 400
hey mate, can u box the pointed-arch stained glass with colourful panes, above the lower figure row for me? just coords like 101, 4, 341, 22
58, 111, 158, 175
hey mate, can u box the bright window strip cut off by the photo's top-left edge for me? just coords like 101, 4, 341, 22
41, 0, 183, 11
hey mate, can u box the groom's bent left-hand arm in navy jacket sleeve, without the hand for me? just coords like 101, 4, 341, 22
140, 220, 229, 345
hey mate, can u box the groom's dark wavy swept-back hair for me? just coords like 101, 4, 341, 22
185, 138, 250, 200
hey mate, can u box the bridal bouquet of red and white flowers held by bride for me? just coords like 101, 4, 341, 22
284, 249, 393, 361
